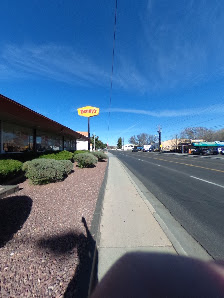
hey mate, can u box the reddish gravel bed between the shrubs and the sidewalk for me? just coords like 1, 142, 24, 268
0, 162, 107, 297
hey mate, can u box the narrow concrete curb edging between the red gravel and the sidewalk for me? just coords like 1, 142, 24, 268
88, 158, 109, 297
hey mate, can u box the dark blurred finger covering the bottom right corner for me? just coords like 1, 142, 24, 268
91, 252, 224, 298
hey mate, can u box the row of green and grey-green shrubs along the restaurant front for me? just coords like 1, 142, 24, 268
0, 150, 107, 184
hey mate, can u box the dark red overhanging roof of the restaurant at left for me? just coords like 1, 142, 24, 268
0, 94, 85, 139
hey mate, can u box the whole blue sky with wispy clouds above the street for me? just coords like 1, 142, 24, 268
0, 0, 224, 145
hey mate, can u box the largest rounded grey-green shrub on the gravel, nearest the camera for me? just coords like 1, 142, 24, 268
23, 159, 73, 184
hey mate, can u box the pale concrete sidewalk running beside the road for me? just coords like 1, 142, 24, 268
98, 153, 176, 280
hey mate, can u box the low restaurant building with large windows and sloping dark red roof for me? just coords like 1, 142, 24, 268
0, 94, 88, 153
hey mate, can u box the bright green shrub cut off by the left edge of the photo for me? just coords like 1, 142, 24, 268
0, 159, 23, 182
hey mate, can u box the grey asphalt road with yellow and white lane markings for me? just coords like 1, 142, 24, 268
111, 151, 224, 260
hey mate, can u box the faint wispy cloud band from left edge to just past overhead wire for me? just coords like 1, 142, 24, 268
0, 44, 150, 93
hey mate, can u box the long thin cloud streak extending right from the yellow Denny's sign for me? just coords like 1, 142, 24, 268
101, 104, 224, 118
